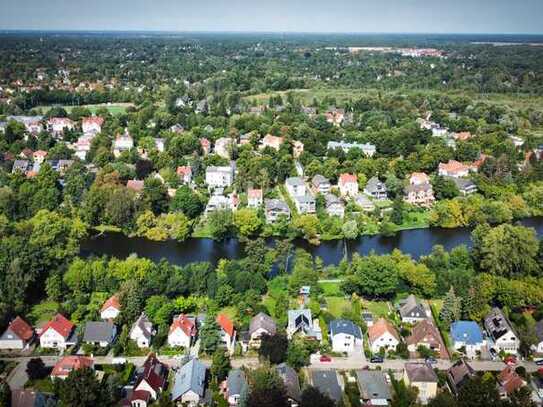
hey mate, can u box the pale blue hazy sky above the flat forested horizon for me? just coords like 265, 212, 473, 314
0, 0, 543, 34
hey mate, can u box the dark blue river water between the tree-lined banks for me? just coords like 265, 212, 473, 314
81, 217, 543, 266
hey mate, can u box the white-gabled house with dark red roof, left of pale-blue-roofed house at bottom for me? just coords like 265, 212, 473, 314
129, 353, 168, 407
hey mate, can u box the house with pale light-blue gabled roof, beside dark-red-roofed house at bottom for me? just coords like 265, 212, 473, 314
172, 359, 206, 406
